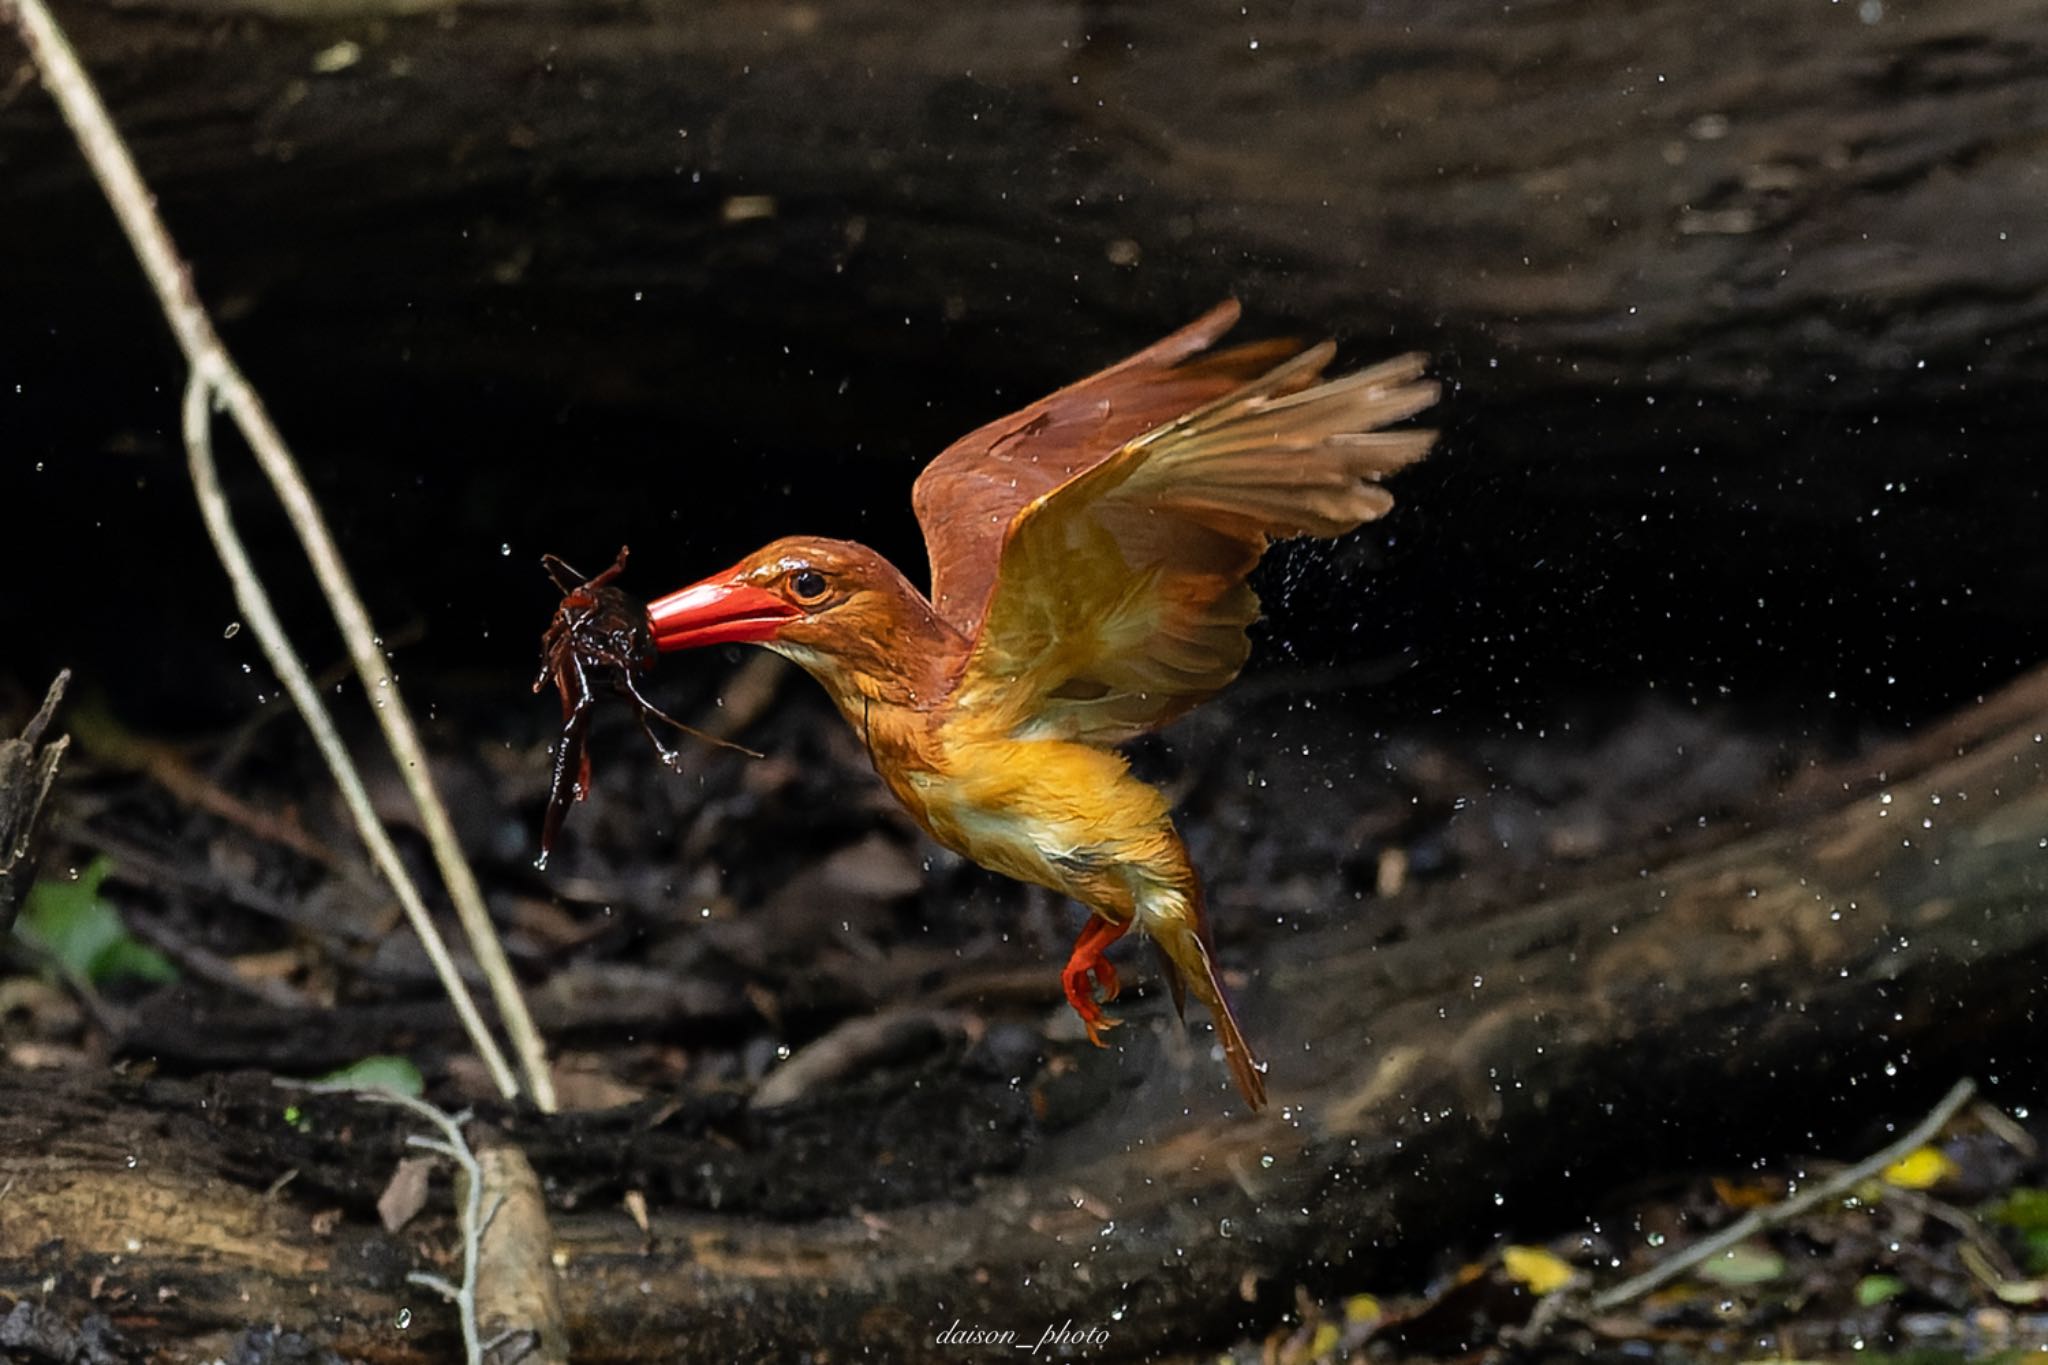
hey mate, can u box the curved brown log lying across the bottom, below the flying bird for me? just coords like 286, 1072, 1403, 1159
0, 673, 2048, 1361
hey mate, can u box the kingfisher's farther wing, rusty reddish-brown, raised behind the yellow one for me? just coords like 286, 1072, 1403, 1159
911, 301, 1294, 639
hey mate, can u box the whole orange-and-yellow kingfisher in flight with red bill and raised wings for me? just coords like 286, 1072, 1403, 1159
561, 303, 1438, 1109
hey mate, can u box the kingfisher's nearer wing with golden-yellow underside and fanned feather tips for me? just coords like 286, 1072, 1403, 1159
958, 334, 1438, 743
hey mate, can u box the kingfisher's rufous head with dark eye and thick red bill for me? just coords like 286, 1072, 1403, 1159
647, 536, 956, 706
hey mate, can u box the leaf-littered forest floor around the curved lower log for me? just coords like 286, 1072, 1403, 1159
12, 659, 2048, 1365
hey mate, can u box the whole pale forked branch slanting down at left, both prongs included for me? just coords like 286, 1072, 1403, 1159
0, 0, 555, 1111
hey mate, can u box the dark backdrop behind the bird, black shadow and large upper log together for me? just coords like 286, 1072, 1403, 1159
0, 4, 2048, 749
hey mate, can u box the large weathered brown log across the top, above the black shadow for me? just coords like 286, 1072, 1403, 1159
0, 0, 2048, 401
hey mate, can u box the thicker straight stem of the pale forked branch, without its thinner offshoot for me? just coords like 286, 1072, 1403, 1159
0, 0, 555, 1111
